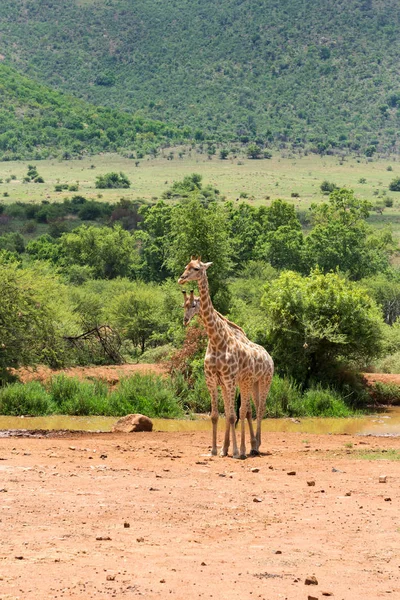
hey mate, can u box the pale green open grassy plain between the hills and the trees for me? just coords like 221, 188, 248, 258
0, 149, 400, 232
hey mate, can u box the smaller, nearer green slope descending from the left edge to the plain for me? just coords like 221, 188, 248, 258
0, 64, 184, 160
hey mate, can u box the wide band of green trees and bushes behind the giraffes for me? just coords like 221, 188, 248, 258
0, 174, 400, 416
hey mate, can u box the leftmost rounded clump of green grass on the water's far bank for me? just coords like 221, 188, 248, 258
0, 381, 52, 417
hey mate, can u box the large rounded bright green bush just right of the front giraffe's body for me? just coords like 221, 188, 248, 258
262, 271, 382, 382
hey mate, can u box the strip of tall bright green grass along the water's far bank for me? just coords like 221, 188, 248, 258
0, 373, 360, 418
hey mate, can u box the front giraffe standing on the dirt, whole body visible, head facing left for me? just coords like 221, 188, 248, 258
178, 256, 274, 458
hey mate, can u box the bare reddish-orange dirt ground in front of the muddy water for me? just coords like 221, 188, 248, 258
0, 432, 400, 600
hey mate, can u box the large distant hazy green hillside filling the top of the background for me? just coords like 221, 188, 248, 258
0, 0, 400, 155
